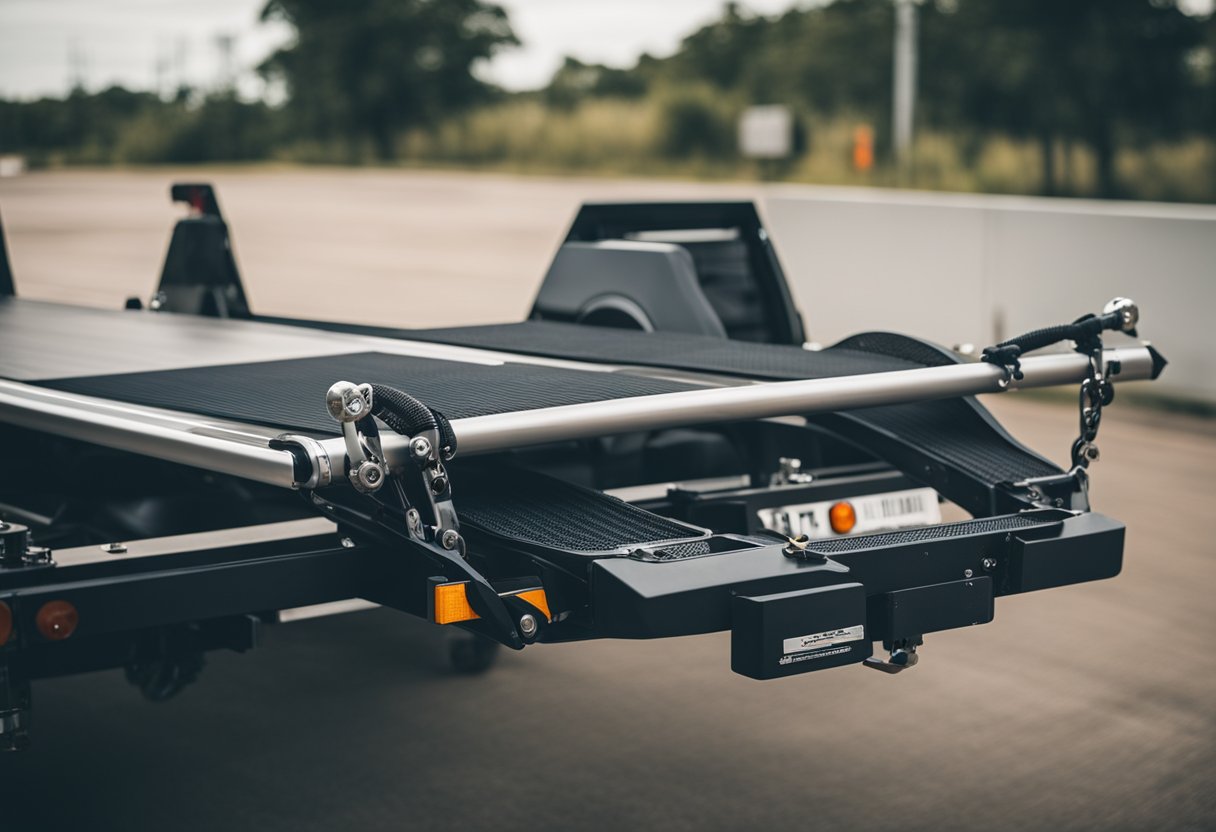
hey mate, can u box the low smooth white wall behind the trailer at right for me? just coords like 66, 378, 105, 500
765, 187, 1216, 401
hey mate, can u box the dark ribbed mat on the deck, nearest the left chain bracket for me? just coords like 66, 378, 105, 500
41, 353, 698, 434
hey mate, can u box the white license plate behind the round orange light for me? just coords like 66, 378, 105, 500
758, 488, 941, 539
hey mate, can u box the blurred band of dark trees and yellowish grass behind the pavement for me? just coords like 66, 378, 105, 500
0, 0, 1216, 201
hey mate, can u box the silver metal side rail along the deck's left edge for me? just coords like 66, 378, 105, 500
0, 381, 295, 488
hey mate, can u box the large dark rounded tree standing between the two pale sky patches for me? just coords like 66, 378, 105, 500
260, 0, 519, 159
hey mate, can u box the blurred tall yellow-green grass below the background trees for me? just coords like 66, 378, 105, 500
362, 94, 1216, 202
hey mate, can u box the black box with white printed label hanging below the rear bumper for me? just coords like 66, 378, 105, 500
731, 584, 874, 679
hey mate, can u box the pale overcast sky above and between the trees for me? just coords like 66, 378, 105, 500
0, 0, 807, 99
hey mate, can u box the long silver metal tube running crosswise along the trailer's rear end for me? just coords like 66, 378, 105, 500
389, 347, 1153, 463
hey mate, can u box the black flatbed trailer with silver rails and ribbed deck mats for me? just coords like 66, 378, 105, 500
0, 185, 1165, 747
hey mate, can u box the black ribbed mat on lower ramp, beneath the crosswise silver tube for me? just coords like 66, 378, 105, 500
452, 468, 706, 552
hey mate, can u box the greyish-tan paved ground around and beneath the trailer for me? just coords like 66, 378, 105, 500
0, 172, 1216, 832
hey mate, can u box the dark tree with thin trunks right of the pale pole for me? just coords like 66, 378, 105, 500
922, 0, 1204, 197
